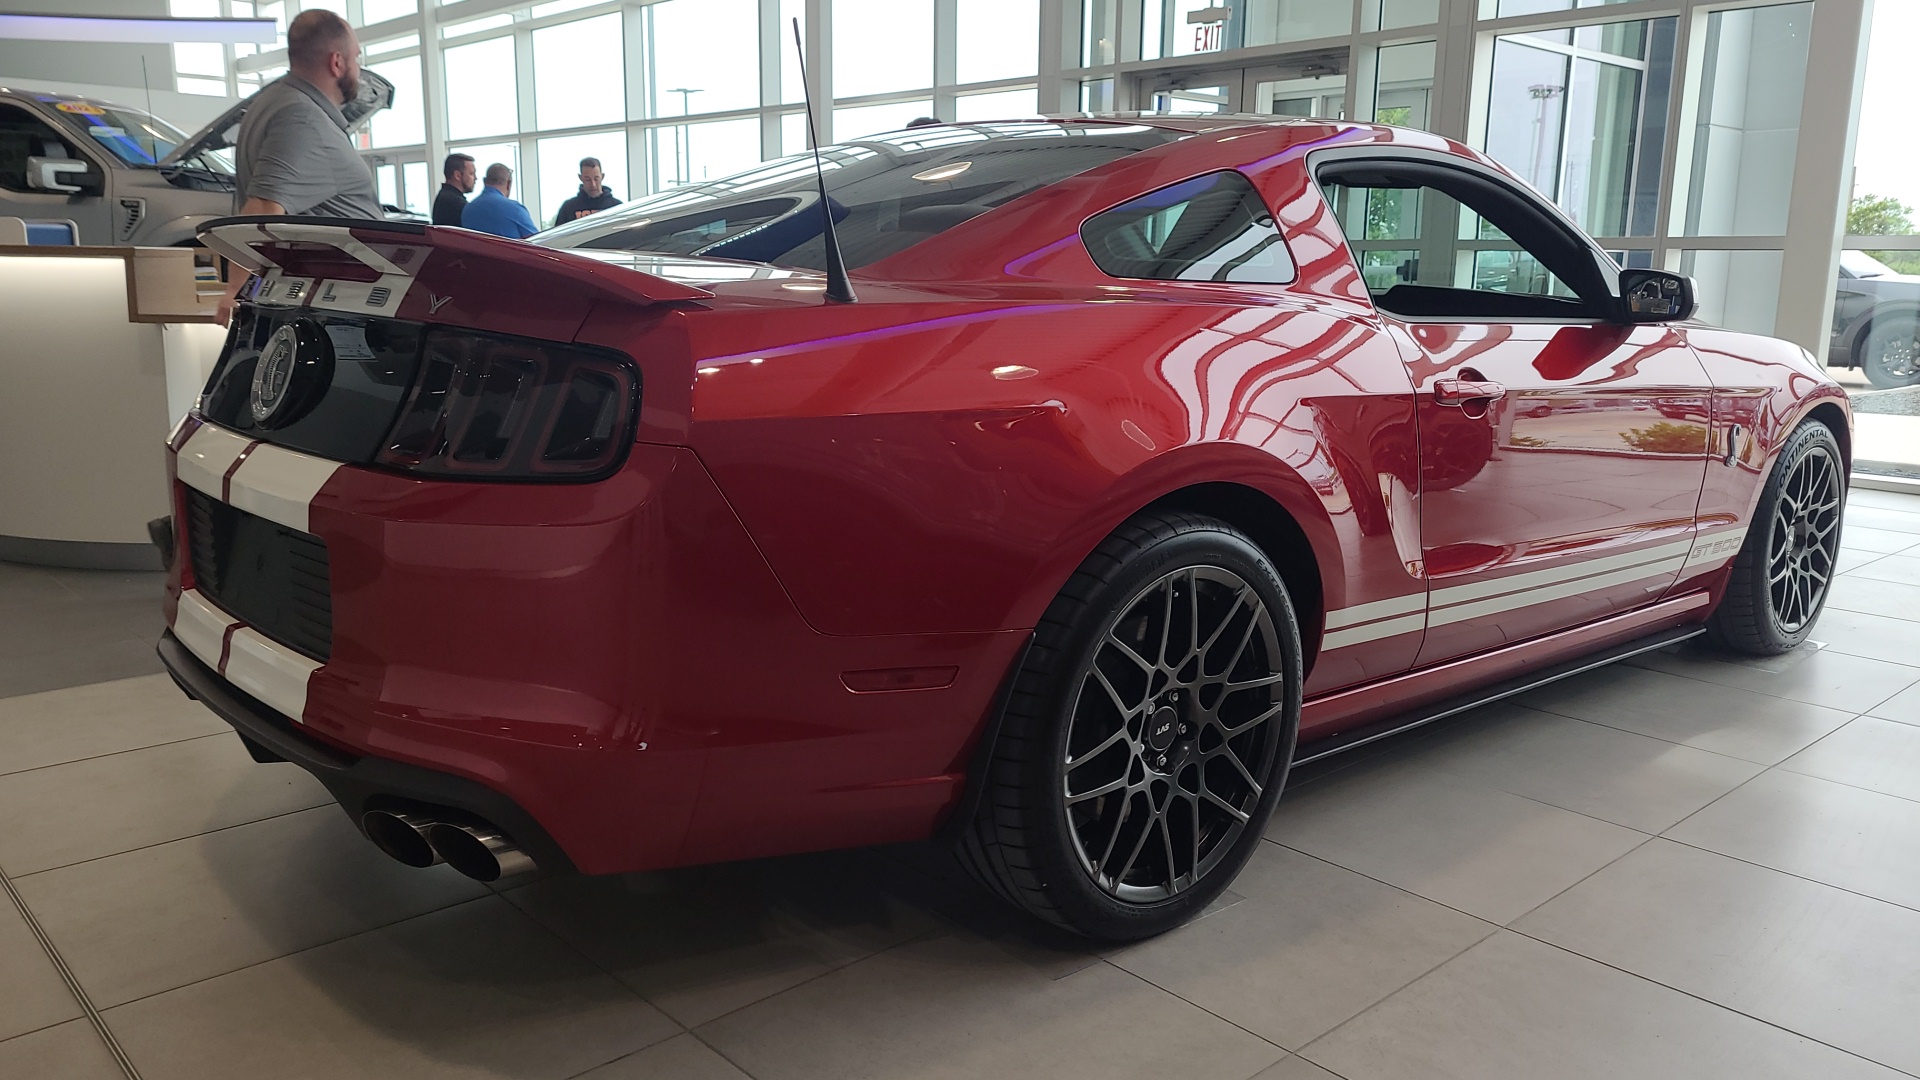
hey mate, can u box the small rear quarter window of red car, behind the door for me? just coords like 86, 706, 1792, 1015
1081, 169, 1294, 284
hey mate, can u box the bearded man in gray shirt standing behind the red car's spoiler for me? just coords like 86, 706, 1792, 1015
234, 8, 384, 221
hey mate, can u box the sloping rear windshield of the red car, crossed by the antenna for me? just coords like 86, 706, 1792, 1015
536, 123, 1181, 269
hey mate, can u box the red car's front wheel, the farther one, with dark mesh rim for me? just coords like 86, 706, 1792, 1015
1707, 421, 1847, 655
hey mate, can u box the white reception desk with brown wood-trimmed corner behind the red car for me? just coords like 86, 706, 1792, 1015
0, 246, 227, 569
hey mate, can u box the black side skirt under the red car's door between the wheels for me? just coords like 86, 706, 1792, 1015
1294, 594, 1707, 767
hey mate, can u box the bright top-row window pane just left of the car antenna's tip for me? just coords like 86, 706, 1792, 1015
645, 0, 756, 115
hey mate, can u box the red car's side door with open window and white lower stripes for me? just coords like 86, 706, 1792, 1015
1317, 152, 1711, 667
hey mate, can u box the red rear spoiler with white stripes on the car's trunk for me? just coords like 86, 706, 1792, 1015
198, 217, 712, 329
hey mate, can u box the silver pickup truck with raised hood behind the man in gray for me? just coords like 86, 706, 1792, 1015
0, 71, 397, 248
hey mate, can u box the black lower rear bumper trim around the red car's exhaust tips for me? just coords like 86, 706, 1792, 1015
157, 630, 572, 871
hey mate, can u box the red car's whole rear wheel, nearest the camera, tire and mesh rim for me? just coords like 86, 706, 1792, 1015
958, 511, 1300, 942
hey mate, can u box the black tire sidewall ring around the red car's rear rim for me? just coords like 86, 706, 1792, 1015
1023, 525, 1302, 940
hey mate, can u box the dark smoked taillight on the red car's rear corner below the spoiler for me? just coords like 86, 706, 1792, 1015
378, 331, 639, 480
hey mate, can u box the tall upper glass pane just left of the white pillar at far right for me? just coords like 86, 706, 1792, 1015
1676, 4, 1812, 236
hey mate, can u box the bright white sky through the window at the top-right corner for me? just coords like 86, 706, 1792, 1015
1853, 0, 1920, 216
